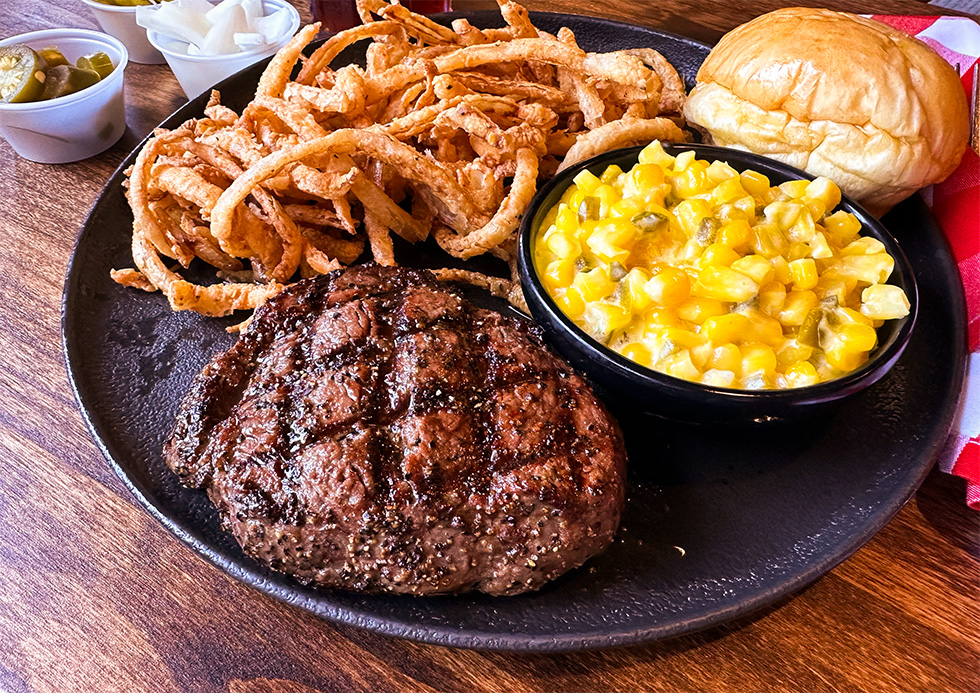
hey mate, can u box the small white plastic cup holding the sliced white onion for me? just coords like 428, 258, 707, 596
146, 0, 300, 99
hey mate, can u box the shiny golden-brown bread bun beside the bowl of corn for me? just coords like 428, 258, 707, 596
684, 8, 969, 216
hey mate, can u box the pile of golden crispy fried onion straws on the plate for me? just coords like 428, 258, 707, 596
112, 0, 688, 316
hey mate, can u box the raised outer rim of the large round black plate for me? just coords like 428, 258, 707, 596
61, 11, 966, 653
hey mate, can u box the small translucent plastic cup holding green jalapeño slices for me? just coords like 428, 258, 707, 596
0, 29, 129, 164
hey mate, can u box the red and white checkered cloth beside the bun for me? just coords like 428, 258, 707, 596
872, 15, 980, 510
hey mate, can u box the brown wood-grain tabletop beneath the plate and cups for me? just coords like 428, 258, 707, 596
0, 0, 980, 693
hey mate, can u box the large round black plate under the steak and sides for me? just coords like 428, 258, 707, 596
62, 13, 966, 651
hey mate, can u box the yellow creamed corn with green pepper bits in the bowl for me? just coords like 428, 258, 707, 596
534, 142, 909, 389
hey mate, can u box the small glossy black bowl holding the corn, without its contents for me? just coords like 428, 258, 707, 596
518, 144, 918, 424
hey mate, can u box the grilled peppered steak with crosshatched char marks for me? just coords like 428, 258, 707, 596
165, 265, 626, 595
